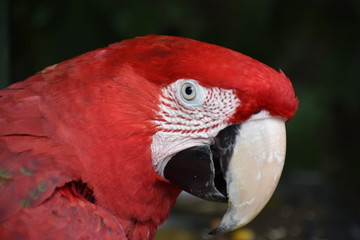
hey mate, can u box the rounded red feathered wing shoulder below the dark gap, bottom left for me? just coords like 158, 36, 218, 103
0, 192, 127, 239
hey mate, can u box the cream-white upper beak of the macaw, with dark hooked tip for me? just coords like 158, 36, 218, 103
211, 111, 286, 233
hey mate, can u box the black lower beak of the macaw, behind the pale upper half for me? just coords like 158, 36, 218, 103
164, 125, 239, 202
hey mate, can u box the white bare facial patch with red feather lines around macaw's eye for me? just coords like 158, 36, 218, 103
151, 79, 240, 176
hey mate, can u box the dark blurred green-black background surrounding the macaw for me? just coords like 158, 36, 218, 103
0, 0, 360, 240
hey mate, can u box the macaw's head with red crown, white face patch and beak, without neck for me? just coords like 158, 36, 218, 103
103, 36, 298, 232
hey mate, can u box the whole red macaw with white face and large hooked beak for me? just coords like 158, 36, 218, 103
0, 35, 298, 239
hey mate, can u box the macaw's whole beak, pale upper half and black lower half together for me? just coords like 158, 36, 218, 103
164, 111, 286, 234
